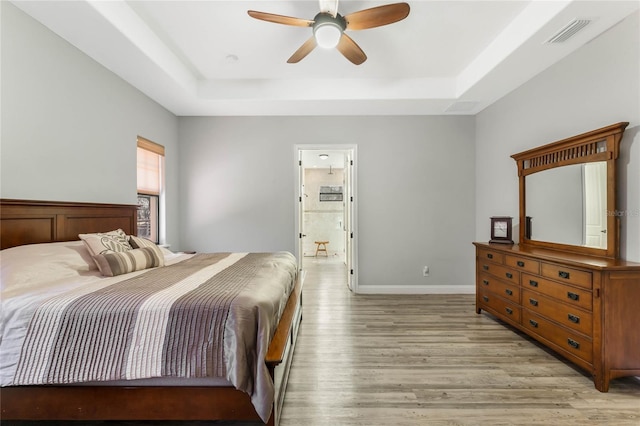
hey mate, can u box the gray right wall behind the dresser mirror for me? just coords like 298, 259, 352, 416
476, 12, 640, 262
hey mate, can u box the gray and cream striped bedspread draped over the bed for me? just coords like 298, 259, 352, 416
13, 252, 297, 421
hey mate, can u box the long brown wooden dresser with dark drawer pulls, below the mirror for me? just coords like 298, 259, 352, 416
474, 243, 640, 392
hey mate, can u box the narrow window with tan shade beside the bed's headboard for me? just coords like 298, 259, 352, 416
137, 136, 164, 243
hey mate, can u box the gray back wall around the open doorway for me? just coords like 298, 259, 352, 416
180, 116, 475, 291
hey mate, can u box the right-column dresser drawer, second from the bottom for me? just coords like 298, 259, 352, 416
522, 289, 593, 337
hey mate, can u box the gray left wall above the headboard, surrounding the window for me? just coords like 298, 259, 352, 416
0, 1, 179, 248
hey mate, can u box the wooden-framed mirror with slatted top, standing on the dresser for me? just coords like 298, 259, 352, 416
512, 123, 628, 258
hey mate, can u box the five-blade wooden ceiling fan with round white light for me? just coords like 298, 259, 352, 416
247, 0, 409, 65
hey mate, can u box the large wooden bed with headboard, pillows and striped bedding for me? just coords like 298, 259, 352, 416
0, 199, 303, 425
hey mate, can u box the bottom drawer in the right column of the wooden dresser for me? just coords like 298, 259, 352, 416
522, 309, 593, 363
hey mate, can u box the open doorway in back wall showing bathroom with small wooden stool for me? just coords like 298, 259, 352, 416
296, 145, 357, 292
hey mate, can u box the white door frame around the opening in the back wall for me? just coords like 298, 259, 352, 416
294, 144, 358, 293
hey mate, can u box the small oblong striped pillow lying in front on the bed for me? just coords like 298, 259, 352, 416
93, 246, 164, 277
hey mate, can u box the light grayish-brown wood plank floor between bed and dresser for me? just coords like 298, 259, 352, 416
6, 258, 640, 426
